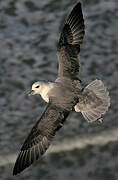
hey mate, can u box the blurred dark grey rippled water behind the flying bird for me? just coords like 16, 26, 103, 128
0, 0, 118, 180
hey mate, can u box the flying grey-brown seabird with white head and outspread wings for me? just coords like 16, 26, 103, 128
13, 2, 110, 175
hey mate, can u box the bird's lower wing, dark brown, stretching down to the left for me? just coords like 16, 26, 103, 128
13, 103, 69, 175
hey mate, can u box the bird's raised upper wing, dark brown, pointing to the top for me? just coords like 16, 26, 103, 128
57, 2, 85, 79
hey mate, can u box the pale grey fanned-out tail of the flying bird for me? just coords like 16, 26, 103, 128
75, 80, 110, 122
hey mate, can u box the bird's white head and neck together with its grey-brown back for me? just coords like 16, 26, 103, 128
32, 77, 82, 111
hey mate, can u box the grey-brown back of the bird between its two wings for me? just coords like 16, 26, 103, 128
49, 78, 81, 111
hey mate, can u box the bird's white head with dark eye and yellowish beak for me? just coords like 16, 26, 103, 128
28, 81, 41, 96
